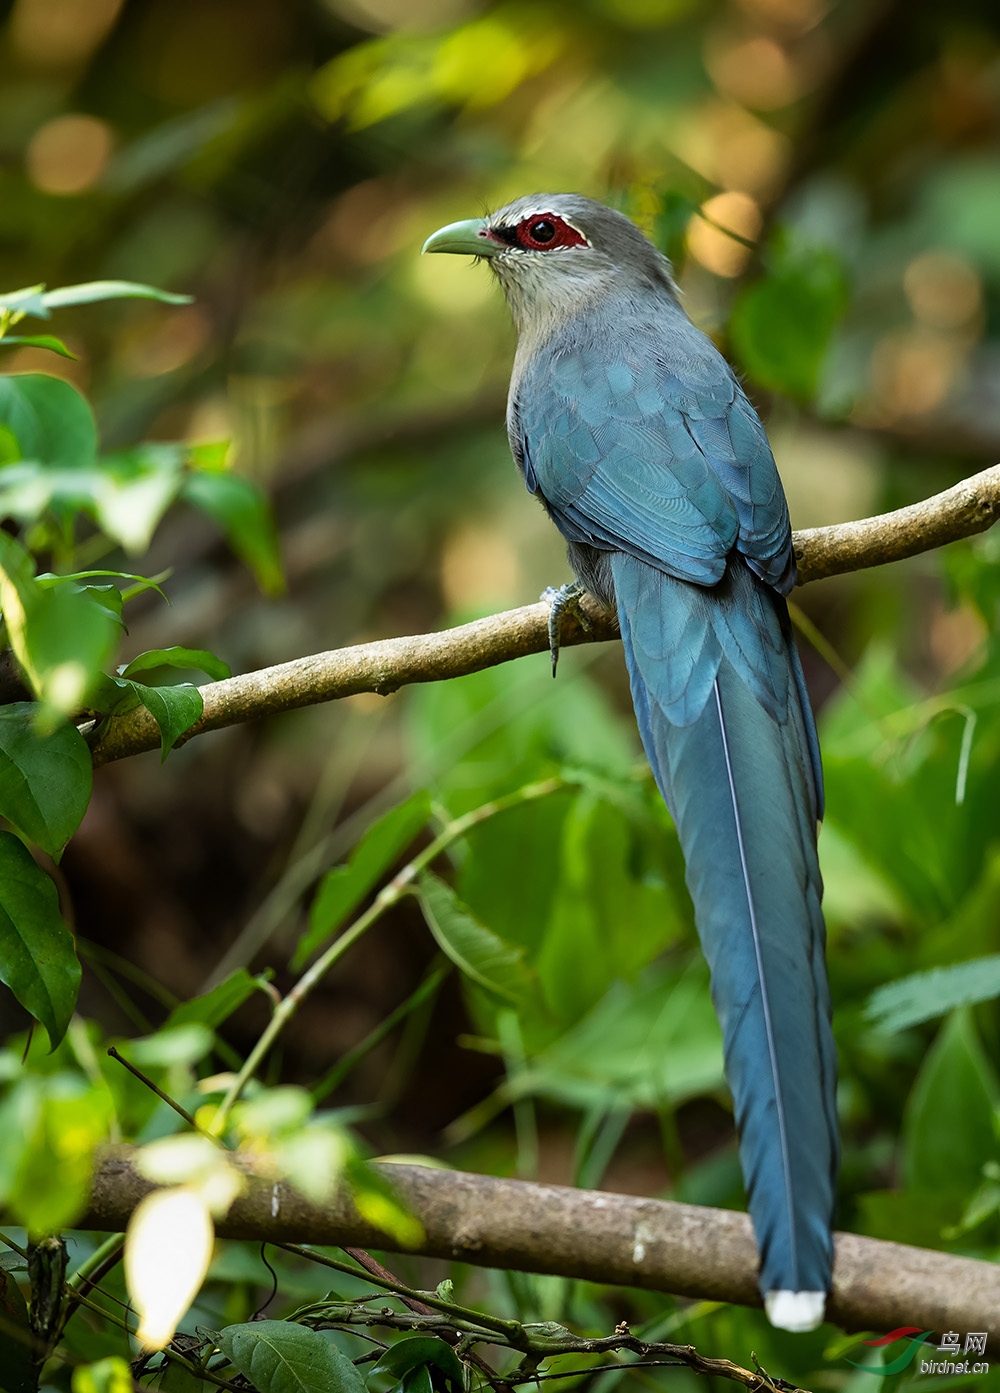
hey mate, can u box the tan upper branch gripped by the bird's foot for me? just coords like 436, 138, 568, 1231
92, 465, 1000, 765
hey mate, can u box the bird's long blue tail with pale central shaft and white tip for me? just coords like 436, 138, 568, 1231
611, 553, 838, 1329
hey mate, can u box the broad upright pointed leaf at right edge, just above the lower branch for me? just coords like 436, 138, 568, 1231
903, 1007, 1000, 1212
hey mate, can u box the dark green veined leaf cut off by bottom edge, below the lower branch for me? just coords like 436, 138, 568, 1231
219, 1321, 365, 1393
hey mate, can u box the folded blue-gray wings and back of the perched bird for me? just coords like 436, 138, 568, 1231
513, 309, 794, 593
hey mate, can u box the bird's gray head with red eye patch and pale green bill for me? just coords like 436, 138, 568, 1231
423, 194, 674, 333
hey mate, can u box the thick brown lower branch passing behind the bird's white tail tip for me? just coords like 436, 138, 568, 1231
81, 1151, 1000, 1340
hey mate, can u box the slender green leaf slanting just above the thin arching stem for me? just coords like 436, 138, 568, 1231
292, 791, 430, 970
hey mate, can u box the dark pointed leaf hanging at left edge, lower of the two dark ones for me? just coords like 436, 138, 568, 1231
0, 832, 79, 1049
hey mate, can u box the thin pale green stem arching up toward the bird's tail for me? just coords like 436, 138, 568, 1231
212, 777, 570, 1135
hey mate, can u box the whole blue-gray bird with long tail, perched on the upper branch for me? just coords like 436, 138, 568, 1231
423, 194, 838, 1330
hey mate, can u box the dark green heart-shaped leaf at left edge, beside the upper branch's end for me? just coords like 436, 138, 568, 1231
0, 702, 93, 858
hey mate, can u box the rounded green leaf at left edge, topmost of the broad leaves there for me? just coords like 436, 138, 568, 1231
0, 372, 97, 469
